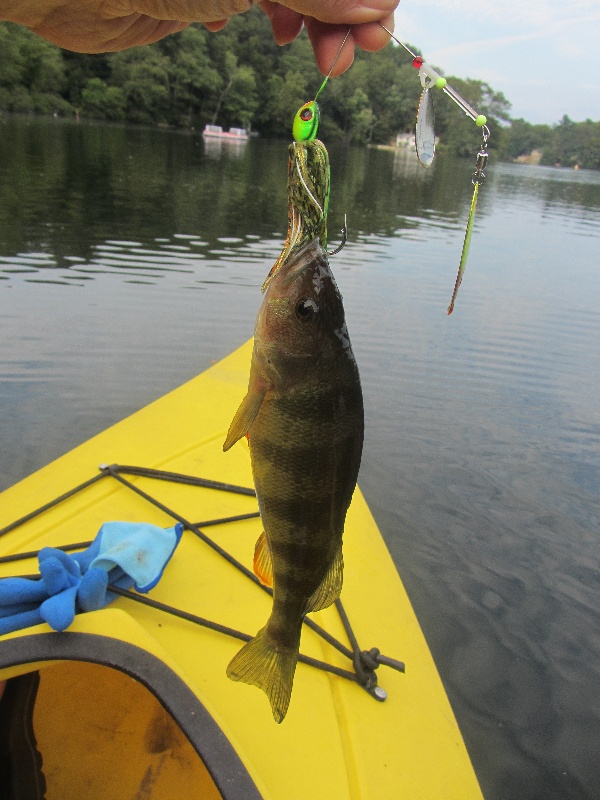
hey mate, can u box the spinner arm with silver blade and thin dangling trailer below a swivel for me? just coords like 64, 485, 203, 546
380, 23, 490, 314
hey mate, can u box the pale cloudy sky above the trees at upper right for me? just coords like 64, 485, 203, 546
395, 0, 600, 124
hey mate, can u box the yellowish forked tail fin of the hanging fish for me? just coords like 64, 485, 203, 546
227, 627, 298, 723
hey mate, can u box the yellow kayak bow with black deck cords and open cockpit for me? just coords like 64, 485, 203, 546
0, 343, 482, 800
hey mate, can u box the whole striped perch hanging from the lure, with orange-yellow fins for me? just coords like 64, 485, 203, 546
223, 237, 364, 723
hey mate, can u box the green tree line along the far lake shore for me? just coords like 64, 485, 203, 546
0, 9, 600, 169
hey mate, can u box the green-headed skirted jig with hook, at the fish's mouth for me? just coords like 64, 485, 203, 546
262, 29, 350, 292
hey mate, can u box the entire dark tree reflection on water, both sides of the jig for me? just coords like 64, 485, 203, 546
0, 114, 494, 274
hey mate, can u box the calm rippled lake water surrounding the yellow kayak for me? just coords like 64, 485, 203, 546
0, 117, 600, 800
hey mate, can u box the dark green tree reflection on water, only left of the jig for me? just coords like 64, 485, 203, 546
0, 119, 286, 262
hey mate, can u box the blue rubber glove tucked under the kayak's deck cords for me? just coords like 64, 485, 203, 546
0, 522, 183, 635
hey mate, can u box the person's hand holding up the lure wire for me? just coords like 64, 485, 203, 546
5, 0, 399, 61
